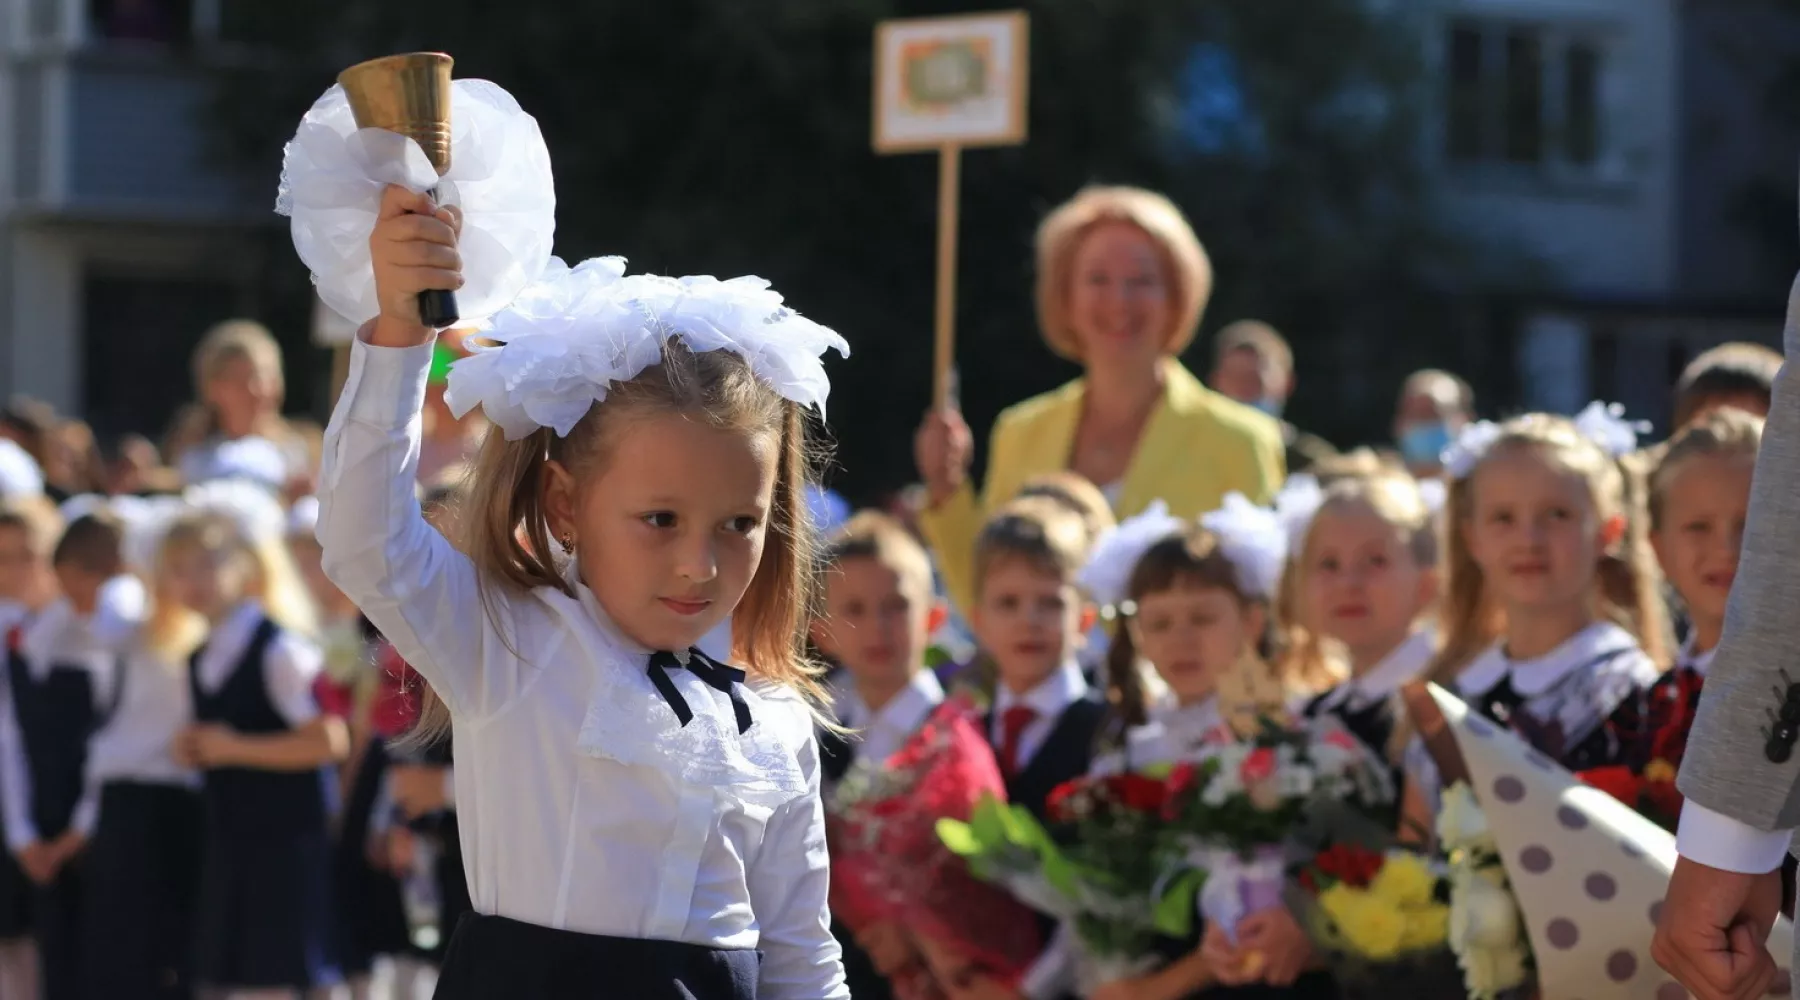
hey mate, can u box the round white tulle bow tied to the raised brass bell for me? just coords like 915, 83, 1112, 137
275, 79, 556, 326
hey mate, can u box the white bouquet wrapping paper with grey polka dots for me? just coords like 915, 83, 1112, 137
1431, 685, 1793, 1000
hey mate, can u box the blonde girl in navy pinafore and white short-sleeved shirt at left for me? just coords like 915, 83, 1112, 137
164, 514, 346, 998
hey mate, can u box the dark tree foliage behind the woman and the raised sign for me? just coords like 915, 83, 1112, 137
218, 0, 1497, 498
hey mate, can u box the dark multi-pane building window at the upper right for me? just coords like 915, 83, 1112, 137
1444, 20, 1606, 171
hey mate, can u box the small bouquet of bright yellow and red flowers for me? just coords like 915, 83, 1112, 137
1294, 844, 1462, 996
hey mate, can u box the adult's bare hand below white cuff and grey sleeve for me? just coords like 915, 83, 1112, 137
1651, 858, 1782, 1000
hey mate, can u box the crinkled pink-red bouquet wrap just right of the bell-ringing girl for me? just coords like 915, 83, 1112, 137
826, 700, 1040, 1000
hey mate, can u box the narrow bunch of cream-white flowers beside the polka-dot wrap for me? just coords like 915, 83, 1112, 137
1438, 782, 1535, 1000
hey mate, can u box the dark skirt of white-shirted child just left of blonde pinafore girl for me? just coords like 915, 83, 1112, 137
81, 781, 202, 1000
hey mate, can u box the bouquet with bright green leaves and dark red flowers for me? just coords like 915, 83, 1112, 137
938, 772, 1192, 982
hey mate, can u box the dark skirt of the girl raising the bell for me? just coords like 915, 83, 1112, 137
434, 915, 761, 1000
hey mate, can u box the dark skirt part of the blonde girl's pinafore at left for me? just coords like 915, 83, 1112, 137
194, 827, 342, 989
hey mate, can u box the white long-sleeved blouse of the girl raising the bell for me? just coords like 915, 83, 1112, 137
319, 340, 850, 1000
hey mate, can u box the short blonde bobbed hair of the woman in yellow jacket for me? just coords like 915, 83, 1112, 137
1037, 185, 1213, 362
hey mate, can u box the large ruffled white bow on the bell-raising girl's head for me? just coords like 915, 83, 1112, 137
445, 257, 850, 441
